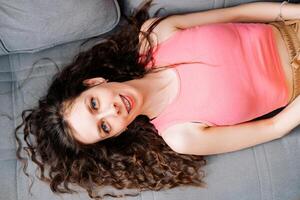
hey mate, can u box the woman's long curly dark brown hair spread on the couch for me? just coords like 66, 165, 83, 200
15, 1, 206, 198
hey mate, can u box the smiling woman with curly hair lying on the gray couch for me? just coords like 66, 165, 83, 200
16, 2, 300, 197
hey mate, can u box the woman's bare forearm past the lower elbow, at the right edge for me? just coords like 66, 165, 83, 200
273, 95, 300, 137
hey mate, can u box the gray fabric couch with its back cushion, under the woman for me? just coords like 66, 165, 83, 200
0, 0, 300, 200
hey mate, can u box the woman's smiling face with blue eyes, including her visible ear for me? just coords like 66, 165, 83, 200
65, 78, 143, 144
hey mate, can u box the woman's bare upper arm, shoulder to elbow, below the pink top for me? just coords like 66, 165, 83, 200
162, 118, 281, 155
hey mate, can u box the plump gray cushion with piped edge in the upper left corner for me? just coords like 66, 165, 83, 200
0, 0, 120, 55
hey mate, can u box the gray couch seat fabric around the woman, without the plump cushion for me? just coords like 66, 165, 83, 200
0, 0, 300, 200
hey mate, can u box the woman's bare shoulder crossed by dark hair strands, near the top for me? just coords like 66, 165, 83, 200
139, 17, 179, 52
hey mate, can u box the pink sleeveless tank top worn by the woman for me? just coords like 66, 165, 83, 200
151, 23, 288, 134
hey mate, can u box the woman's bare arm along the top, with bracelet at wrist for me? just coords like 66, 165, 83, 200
164, 2, 300, 29
